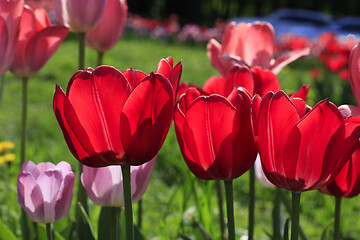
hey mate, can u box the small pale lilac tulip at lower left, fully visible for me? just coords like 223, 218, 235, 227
17, 161, 74, 223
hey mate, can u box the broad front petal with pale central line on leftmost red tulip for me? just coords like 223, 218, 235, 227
68, 66, 130, 158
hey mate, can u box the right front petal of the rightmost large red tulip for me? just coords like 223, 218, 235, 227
283, 100, 345, 191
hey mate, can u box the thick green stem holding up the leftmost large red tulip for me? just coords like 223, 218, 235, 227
121, 165, 134, 240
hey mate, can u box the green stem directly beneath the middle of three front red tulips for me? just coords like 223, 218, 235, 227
224, 180, 235, 240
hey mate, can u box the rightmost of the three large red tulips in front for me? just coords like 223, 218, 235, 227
251, 91, 360, 192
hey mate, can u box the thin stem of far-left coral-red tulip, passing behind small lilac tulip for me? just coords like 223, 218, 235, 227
20, 77, 30, 240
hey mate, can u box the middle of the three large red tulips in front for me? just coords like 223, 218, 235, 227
174, 88, 257, 180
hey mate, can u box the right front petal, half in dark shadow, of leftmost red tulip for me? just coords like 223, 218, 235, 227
120, 73, 175, 165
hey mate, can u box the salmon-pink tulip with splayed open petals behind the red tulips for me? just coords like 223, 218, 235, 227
207, 22, 310, 76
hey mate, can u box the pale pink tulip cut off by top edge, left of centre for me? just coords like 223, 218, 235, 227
53, 0, 107, 33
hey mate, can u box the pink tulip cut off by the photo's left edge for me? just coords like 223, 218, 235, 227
0, 0, 24, 75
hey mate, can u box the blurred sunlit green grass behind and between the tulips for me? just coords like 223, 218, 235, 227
0, 34, 360, 240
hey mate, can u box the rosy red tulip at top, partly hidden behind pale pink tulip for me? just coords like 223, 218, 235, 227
86, 0, 128, 52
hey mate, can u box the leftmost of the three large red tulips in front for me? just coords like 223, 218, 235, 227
53, 66, 175, 167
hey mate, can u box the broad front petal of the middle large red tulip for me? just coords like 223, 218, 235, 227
183, 95, 236, 179
